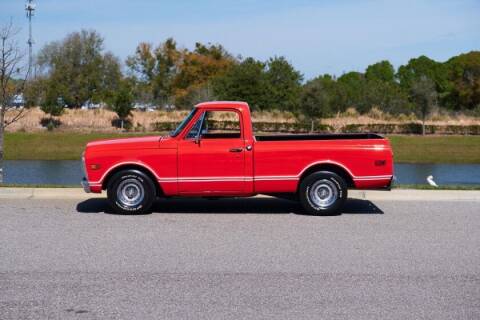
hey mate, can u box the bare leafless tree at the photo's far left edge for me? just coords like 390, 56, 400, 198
0, 22, 30, 183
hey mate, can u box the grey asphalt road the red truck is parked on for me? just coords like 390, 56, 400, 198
0, 198, 480, 320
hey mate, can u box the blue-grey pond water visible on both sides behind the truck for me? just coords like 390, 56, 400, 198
4, 160, 480, 185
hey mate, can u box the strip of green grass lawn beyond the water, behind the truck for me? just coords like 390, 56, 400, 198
5, 132, 480, 163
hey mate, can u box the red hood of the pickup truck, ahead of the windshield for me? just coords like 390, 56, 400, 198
87, 136, 174, 150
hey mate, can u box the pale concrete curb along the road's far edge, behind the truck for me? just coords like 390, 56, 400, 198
0, 187, 480, 201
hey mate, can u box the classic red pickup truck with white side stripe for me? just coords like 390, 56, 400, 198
82, 102, 393, 215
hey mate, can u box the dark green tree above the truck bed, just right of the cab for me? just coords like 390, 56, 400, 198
265, 57, 303, 111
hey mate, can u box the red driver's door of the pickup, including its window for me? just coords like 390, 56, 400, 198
178, 109, 246, 195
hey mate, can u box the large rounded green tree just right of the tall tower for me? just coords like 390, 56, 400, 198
37, 30, 121, 107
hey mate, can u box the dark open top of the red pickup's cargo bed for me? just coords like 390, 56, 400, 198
255, 133, 384, 142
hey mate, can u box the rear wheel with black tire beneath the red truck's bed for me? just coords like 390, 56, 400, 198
299, 171, 347, 216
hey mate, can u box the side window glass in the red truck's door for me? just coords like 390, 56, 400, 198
202, 110, 241, 139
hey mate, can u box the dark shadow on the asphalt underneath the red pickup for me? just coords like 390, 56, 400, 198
77, 198, 383, 215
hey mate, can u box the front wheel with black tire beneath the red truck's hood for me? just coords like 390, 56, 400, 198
107, 170, 156, 214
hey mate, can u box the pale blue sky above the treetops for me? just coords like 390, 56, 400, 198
0, 0, 480, 80
